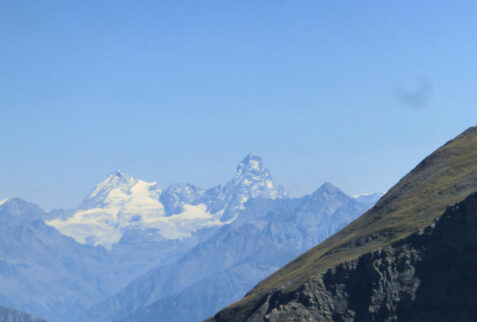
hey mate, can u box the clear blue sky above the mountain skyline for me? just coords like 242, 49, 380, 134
0, 0, 477, 209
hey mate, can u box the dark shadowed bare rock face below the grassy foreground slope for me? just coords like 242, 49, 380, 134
232, 193, 477, 321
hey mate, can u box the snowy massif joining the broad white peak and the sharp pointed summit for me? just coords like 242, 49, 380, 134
47, 153, 285, 248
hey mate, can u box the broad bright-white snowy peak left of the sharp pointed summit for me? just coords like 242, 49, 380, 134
47, 171, 169, 248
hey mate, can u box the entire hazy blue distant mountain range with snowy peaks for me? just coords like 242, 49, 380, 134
0, 154, 379, 321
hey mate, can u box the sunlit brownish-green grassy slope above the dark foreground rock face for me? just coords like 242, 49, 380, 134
208, 127, 477, 321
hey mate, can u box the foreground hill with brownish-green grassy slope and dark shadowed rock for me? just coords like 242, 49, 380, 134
211, 127, 477, 321
